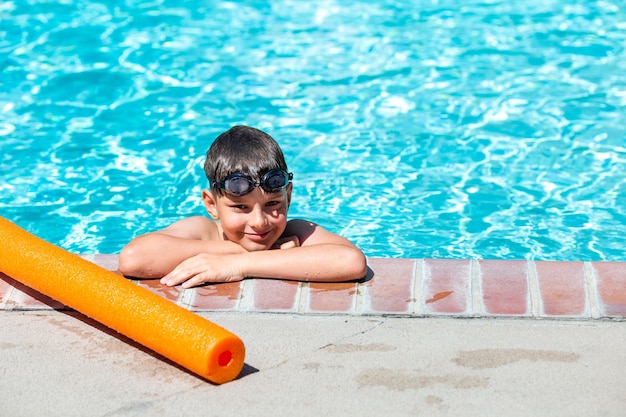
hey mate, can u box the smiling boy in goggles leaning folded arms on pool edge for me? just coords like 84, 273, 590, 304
119, 126, 367, 288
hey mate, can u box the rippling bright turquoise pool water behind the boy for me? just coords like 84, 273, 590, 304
0, 0, 626, 261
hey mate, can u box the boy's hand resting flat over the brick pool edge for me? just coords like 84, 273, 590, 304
161, 253, 244, 288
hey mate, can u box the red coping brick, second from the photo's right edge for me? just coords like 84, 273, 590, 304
535, 262, 589, 317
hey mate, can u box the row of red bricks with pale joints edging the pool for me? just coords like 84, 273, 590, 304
0, 255, 626, 320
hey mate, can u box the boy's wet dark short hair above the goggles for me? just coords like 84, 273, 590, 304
204, 126, 287, 192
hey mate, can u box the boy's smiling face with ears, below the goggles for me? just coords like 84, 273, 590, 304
202, 183, 293, 251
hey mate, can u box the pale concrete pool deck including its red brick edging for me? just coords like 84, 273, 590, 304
0, 255, 626, 416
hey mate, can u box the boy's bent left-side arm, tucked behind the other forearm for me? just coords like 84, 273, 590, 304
119, 216, 245, 278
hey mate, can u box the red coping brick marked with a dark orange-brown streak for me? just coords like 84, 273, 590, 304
422, 259, 472, 315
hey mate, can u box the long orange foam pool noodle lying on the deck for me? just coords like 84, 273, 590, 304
0, 217, 245, 384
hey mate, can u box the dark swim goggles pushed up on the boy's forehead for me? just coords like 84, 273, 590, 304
209, 169, 293, 197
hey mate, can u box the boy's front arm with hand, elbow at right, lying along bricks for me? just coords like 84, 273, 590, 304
161, 220, 367, 288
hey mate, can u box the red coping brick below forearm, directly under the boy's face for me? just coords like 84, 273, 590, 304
252, 279, 300, 312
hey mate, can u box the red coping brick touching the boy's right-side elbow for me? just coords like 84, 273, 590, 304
363, 258, 416, 314
